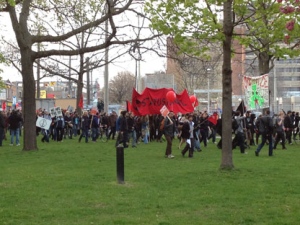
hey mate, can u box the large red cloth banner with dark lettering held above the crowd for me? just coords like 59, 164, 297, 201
131, 88, 194, 116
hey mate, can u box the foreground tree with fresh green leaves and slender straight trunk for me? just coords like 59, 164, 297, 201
147, 0, 299, 168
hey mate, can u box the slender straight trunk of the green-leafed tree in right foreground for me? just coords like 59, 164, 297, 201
220, 0, 234, 169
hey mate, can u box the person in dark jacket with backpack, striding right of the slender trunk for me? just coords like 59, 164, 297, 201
255, 110, 274, 156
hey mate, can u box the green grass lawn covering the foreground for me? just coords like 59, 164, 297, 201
0, 134, 300, 225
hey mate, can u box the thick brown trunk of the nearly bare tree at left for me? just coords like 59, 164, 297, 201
20, 48, 38, 151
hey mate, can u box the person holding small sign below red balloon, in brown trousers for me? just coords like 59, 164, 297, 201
164, 111, 176, 159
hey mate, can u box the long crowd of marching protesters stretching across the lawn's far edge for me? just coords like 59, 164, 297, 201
0, 109, 300, 159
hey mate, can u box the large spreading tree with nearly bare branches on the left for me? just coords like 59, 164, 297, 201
0, 0, 162, 150
